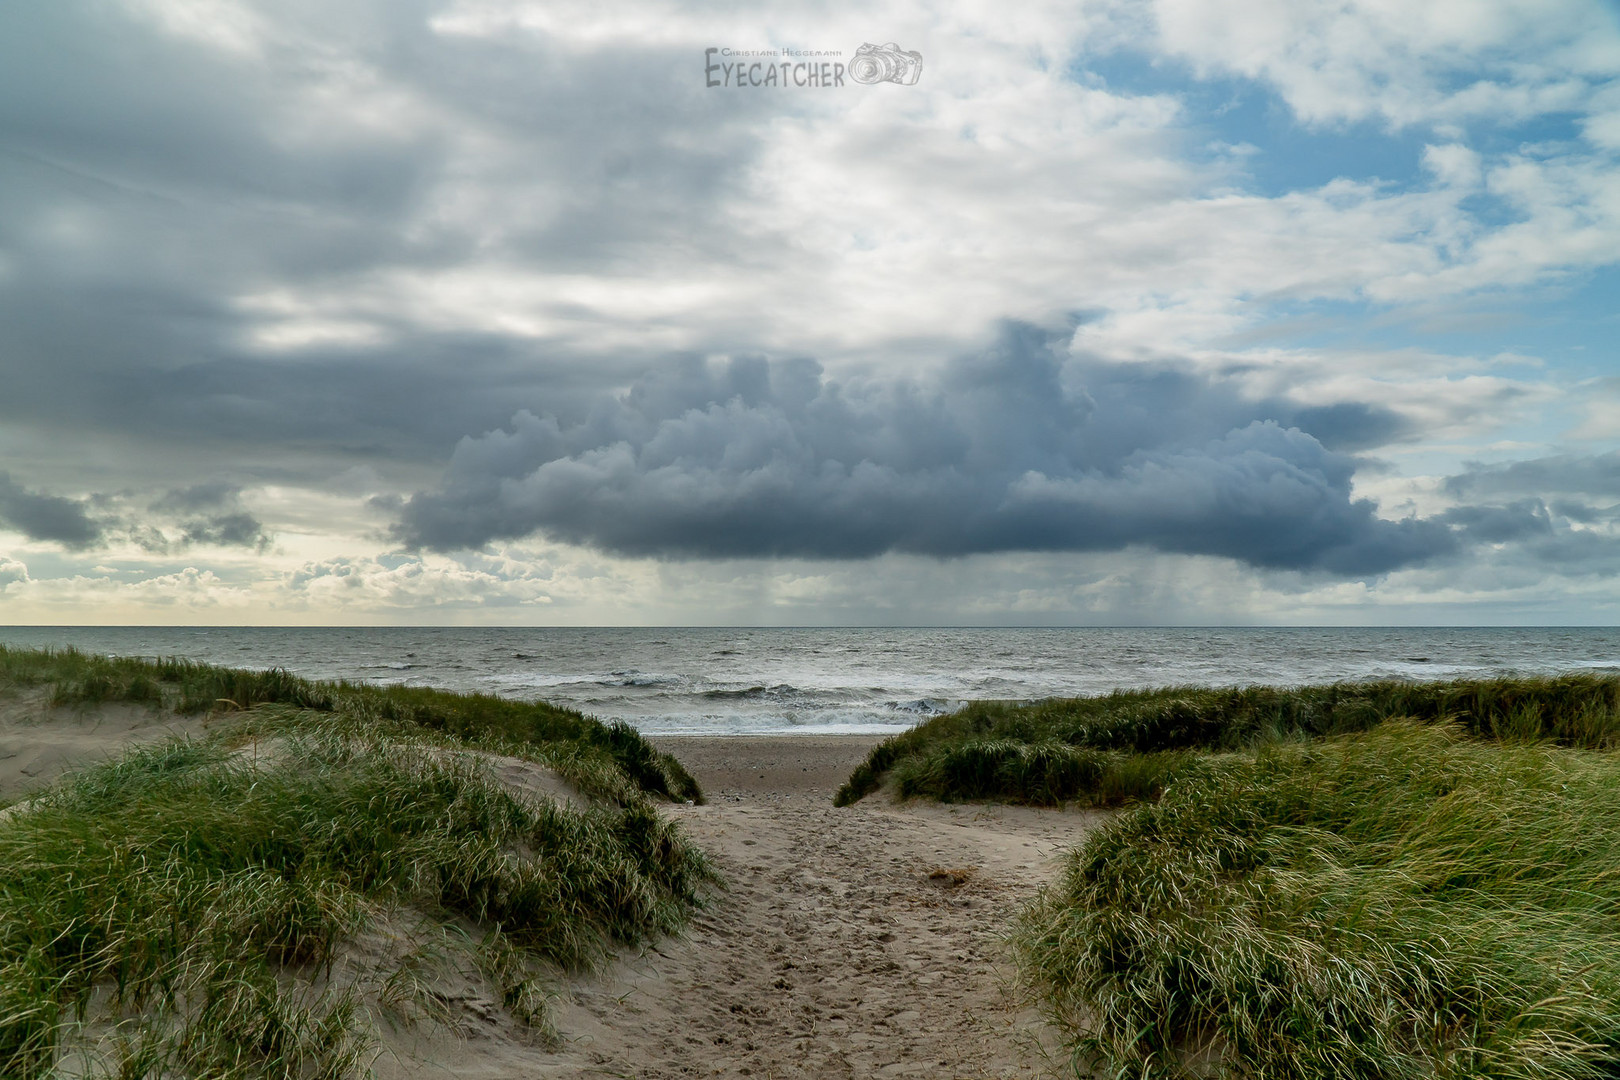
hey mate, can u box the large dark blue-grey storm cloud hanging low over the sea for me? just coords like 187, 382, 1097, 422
399, 327, 1455, 575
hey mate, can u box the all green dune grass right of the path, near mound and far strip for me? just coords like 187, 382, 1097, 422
838, 675, 1620, 1080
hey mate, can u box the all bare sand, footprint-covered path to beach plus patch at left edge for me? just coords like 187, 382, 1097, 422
0, 695, 1097, 1080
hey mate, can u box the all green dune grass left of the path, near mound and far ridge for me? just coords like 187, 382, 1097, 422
0, 646, 718, 1080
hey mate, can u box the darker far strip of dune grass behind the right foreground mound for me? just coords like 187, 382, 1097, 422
834, 675, 1620, 806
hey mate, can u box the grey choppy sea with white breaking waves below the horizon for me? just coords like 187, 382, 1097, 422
0, 627, 1620, 735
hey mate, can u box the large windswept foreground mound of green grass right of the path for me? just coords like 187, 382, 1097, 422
1017, 718, 1620, 1080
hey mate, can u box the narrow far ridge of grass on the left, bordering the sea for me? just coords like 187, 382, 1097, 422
0, 646, 703, 801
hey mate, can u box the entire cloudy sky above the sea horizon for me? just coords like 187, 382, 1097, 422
0, 0, 1620, 625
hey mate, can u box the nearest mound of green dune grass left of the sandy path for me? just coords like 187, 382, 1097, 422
0, 719, 713, 1080
